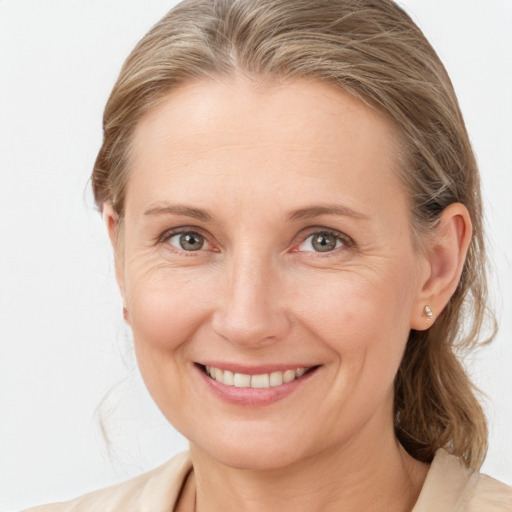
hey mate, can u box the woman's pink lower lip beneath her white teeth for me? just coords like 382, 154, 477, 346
196, 365, 320, 407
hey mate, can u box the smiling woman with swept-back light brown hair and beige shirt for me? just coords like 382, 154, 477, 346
23, 0, 512, 512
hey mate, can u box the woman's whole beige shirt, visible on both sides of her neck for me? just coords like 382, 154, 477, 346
25, 450, 512, 512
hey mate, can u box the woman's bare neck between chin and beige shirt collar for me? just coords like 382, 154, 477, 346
191, 420, 428, 512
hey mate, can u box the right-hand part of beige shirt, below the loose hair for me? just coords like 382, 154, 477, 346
412, 450, 512, 512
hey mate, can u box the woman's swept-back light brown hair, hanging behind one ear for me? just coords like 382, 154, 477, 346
92, 0, 496, 469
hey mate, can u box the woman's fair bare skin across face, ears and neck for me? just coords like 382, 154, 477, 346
104, 76, 471, 512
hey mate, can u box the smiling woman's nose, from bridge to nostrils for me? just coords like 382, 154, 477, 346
212, 254, 291, 347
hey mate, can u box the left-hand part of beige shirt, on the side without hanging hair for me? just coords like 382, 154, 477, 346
20, 452, 192, 512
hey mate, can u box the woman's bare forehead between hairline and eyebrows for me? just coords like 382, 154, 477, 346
127, 77, 406, 217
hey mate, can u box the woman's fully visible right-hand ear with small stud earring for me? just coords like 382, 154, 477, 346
411, 203, 473, 331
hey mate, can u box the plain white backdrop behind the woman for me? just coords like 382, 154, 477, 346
0, 0, 512, 512
